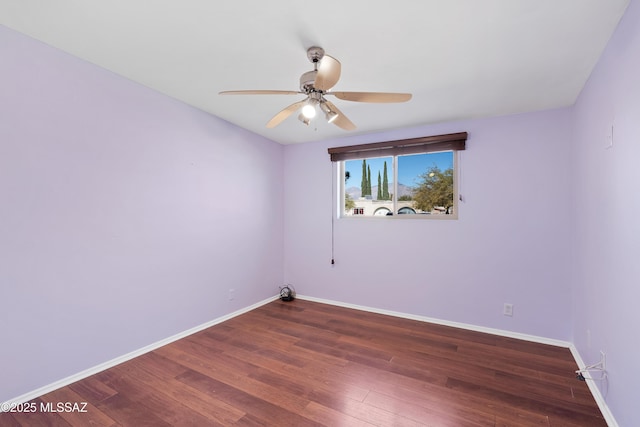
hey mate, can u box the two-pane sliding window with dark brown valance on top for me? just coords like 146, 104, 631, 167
329, 132, 467, 219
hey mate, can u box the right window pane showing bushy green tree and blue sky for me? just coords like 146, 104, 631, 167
397, 151, 455, 215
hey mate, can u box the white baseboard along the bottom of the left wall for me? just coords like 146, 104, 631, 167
0, 295, 279, 412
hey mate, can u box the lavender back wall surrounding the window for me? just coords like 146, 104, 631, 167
285, 109, 571, 340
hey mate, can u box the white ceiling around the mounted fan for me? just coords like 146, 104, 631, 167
0, 0, 629, 144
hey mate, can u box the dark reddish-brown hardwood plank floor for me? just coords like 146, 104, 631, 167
0, 300, 606, 427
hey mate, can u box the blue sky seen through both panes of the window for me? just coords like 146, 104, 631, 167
345, 151, 453, 187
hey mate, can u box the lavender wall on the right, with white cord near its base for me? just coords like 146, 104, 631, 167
572, 0, 640, 426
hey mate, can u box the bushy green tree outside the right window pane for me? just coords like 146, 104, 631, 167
413, 166, 453, 212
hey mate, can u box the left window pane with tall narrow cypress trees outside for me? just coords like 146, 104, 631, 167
344, 157, 393, 217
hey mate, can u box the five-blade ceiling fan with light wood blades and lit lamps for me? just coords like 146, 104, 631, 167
220, 46, 411, 130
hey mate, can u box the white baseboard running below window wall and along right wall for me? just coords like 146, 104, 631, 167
296, 295, 618, 427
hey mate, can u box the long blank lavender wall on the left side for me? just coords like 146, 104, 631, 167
0, 26, 283, 402
